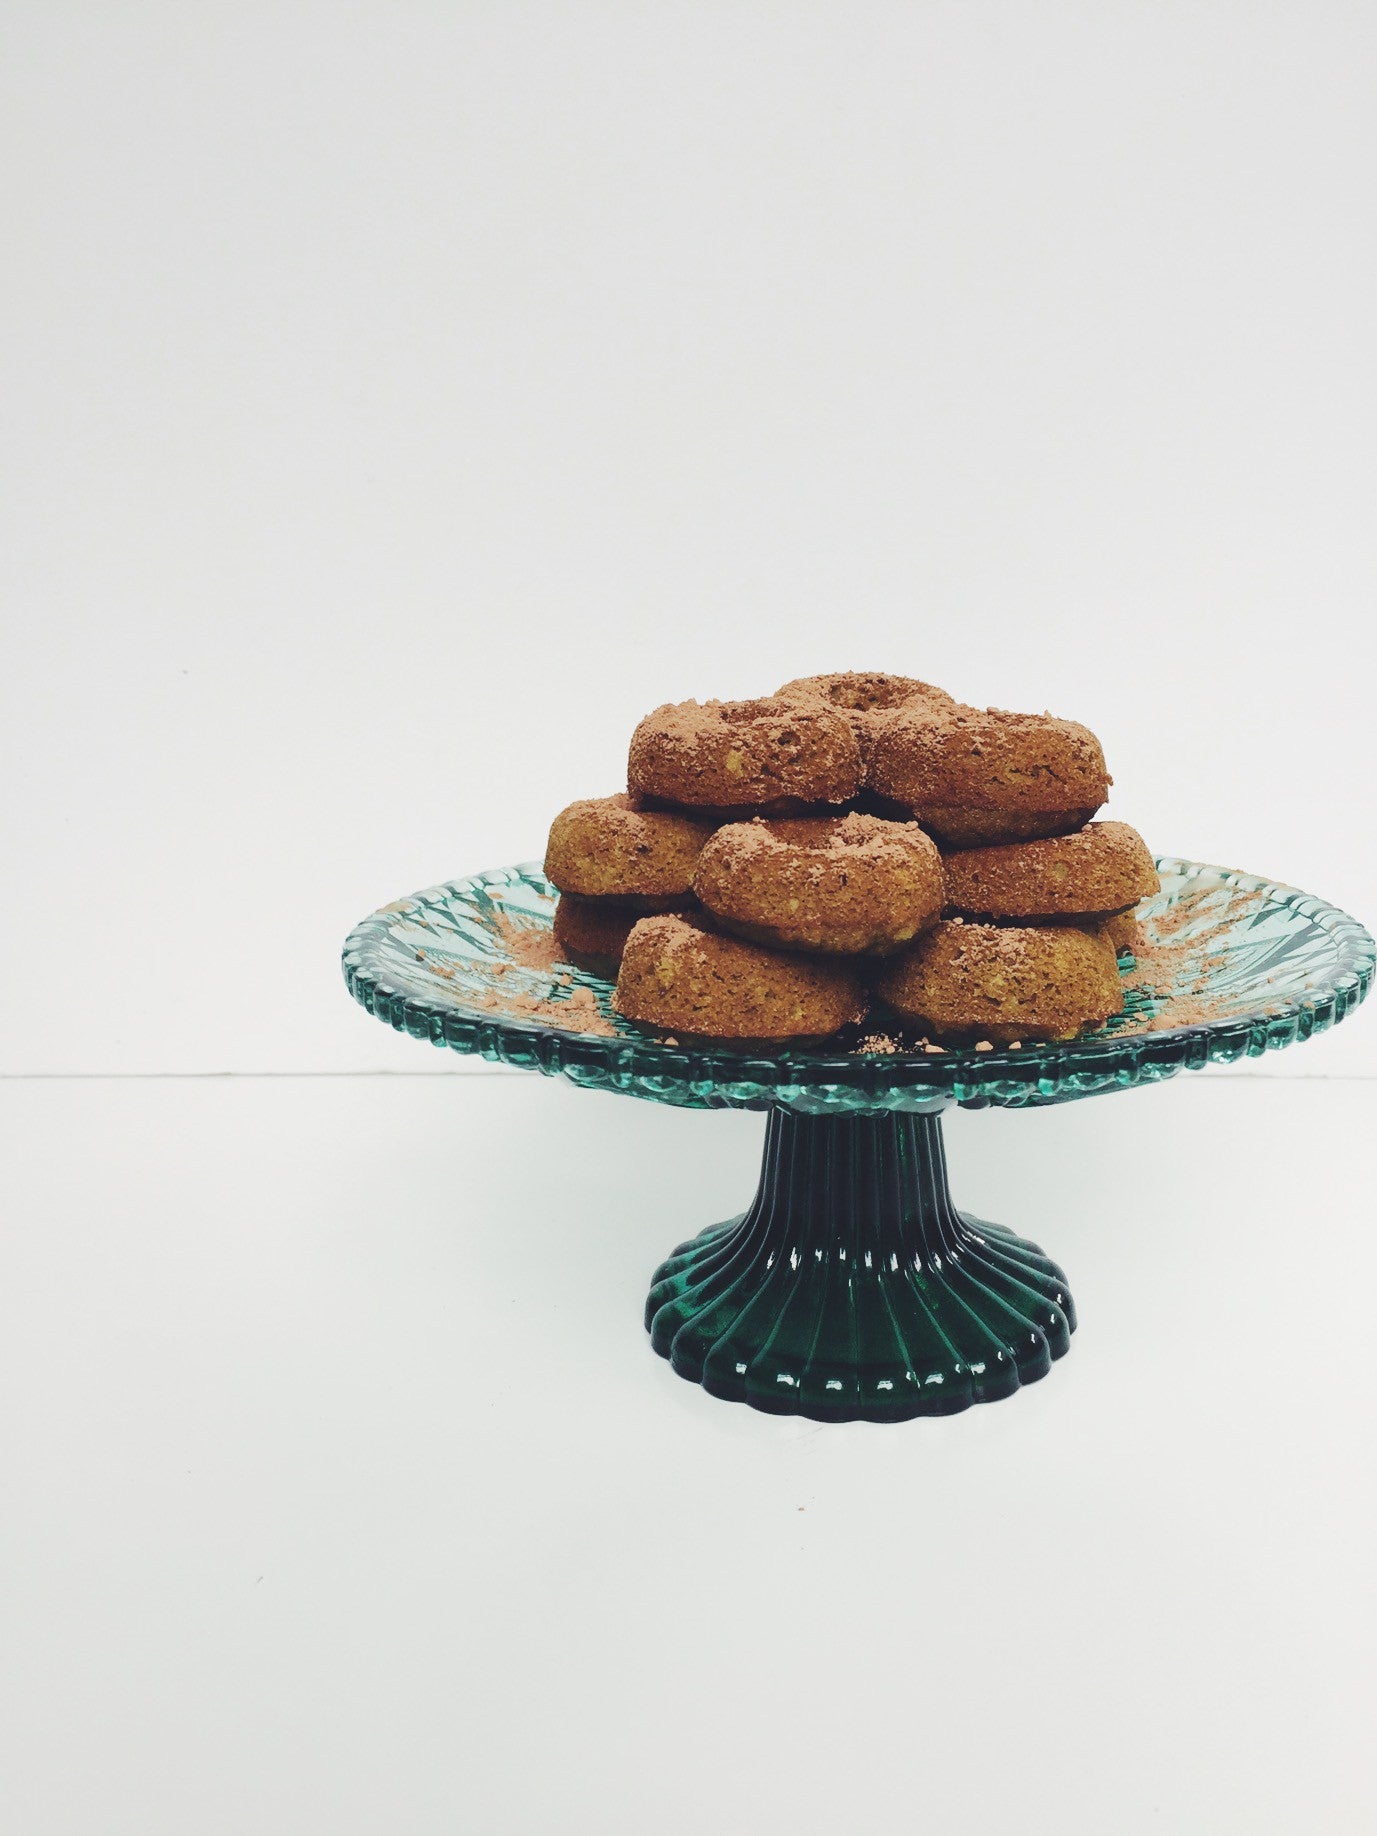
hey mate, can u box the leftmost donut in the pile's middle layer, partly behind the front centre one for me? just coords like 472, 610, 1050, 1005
545, 791, 712, 912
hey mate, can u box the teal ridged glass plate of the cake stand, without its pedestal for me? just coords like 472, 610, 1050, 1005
343, 857, 1373, 1114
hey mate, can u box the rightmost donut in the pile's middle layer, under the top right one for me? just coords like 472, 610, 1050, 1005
946, 823, 1160, 918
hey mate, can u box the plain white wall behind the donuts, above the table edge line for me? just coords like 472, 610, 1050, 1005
0, 0, 1377, 1074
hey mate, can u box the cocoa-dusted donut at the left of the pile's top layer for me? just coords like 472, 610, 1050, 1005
626, 701, 861, 817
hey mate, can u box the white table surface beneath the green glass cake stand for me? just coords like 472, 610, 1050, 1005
0, 1061, 1377, 1836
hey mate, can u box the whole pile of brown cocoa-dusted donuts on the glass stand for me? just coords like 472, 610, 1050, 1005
545, 674, 1159, 1047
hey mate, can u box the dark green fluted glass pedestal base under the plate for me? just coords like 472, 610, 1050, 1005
646, 1109, 1076, 1421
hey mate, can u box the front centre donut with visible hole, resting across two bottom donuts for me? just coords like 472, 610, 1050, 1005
694, 813, 944, 955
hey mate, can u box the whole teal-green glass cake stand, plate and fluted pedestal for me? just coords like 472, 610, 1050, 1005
343, 859, 1373, 1421
